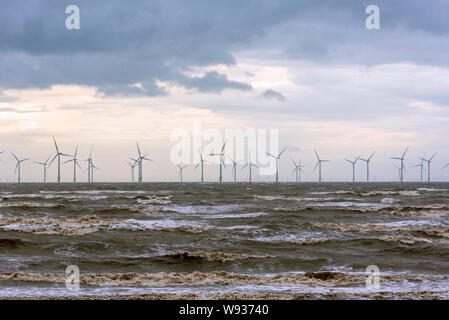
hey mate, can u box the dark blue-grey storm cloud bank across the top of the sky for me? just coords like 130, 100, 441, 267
0, 0, 449, 96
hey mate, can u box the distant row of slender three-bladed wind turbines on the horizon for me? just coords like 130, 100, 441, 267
0, 137, 449, 183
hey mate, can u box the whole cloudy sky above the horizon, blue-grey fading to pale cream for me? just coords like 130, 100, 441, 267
0, 0, 449, 182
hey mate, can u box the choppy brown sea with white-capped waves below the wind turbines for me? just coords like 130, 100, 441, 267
0, 183, 449, 299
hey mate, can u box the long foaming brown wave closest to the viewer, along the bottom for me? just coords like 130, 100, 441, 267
0, 271, 448, 287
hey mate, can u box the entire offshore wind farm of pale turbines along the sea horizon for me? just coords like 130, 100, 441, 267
0, 137, 449, 183
